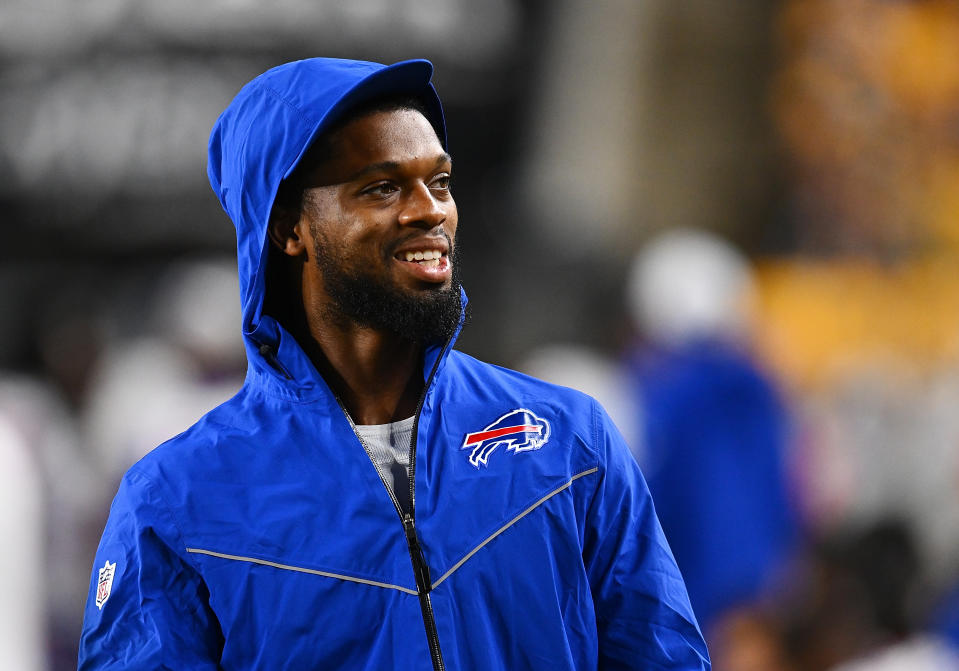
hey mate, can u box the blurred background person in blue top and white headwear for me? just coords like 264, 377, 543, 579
628, 229, 800, 637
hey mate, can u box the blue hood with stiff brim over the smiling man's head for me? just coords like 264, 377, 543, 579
207, 58, 446, 356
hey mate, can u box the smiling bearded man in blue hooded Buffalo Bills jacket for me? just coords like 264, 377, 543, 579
80, 59, 709, 671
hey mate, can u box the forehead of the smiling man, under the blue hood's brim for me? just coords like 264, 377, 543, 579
310, 108, 446, 185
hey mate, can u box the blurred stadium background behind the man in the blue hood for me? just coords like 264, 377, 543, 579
0, 0, 959, 671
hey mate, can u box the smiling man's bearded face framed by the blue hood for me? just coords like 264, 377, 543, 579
299, 109, 460, 341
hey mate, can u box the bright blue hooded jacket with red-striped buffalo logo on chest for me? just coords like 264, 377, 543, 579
80, 59, 709, 671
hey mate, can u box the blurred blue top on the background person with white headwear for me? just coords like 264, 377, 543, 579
632, 338, 800, 630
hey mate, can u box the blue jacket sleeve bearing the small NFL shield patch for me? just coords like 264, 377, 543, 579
79, 471, 222, 671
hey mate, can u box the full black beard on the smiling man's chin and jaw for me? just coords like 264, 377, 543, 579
313, 234, 462, 344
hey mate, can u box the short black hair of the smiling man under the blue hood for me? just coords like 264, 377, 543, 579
270, 94, 440, 219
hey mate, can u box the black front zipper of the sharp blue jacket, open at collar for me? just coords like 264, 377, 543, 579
333, 337, 452, 671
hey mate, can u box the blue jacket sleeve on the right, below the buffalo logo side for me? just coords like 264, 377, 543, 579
584, 404, 710, 671
